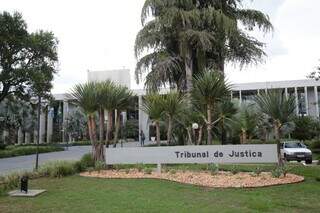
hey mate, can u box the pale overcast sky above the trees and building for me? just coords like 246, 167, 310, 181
0, 0, 320, 93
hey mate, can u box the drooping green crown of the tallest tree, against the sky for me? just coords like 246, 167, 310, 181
135, 0, 272, 91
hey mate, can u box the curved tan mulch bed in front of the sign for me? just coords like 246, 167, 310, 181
80, 169, 304, 188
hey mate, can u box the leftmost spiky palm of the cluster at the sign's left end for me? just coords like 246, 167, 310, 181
70, 82, 105, 162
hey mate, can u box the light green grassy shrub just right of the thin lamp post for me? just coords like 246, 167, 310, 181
39, 161, 76, 178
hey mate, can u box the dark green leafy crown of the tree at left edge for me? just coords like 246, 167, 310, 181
0, 12, 58, 102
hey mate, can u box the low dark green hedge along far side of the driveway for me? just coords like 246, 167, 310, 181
0, 145, 64, 158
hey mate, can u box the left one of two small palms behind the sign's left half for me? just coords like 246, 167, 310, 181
141, 93, 164, 146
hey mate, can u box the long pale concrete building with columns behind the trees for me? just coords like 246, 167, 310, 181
30, 69, 320, 145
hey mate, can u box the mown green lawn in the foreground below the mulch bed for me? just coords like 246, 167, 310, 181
0, 166, 320, 213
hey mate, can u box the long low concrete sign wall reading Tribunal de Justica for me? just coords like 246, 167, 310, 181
106, 144, 278, 165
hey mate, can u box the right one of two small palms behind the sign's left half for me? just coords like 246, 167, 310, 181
162, 91, 186, 144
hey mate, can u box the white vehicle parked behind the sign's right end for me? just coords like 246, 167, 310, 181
280, 141, 312, 164
